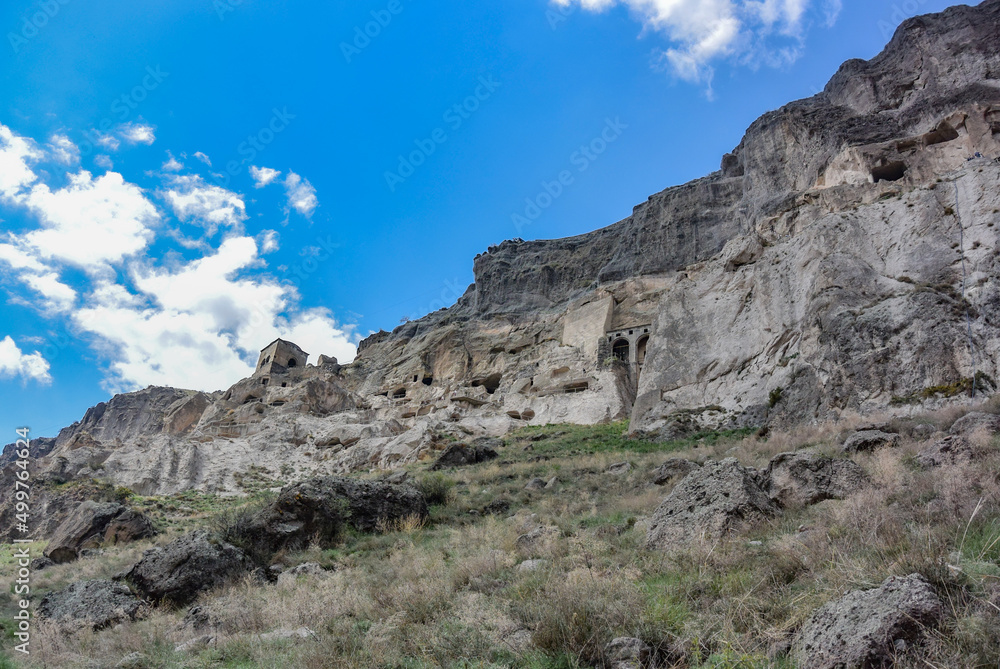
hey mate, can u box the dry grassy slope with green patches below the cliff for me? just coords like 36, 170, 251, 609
0, 414, 1000, 669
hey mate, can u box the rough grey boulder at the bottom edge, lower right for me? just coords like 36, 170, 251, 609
792, 574, 942, 669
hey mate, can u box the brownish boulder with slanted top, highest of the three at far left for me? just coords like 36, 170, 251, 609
45, 501, 156, 564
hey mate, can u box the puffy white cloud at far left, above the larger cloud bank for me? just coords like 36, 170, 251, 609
20, 170, 159, 272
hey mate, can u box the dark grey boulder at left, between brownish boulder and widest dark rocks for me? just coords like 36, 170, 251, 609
116, 530, 253, 606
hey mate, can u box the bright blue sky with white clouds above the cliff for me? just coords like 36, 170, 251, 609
0, 0, 968, 436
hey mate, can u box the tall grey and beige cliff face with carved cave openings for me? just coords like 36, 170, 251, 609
3, 0, 1000, 500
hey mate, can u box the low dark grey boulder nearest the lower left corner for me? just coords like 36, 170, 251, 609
38, 580, 142, 630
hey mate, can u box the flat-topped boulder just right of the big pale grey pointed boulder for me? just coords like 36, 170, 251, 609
764, 453, 868, 506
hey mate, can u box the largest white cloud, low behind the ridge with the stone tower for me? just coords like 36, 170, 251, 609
76, 237, 355, 390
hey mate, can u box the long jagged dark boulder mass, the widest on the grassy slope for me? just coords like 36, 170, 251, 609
249, 476, 427, 554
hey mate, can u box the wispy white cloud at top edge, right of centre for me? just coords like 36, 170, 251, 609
553, 0, 840, 86
